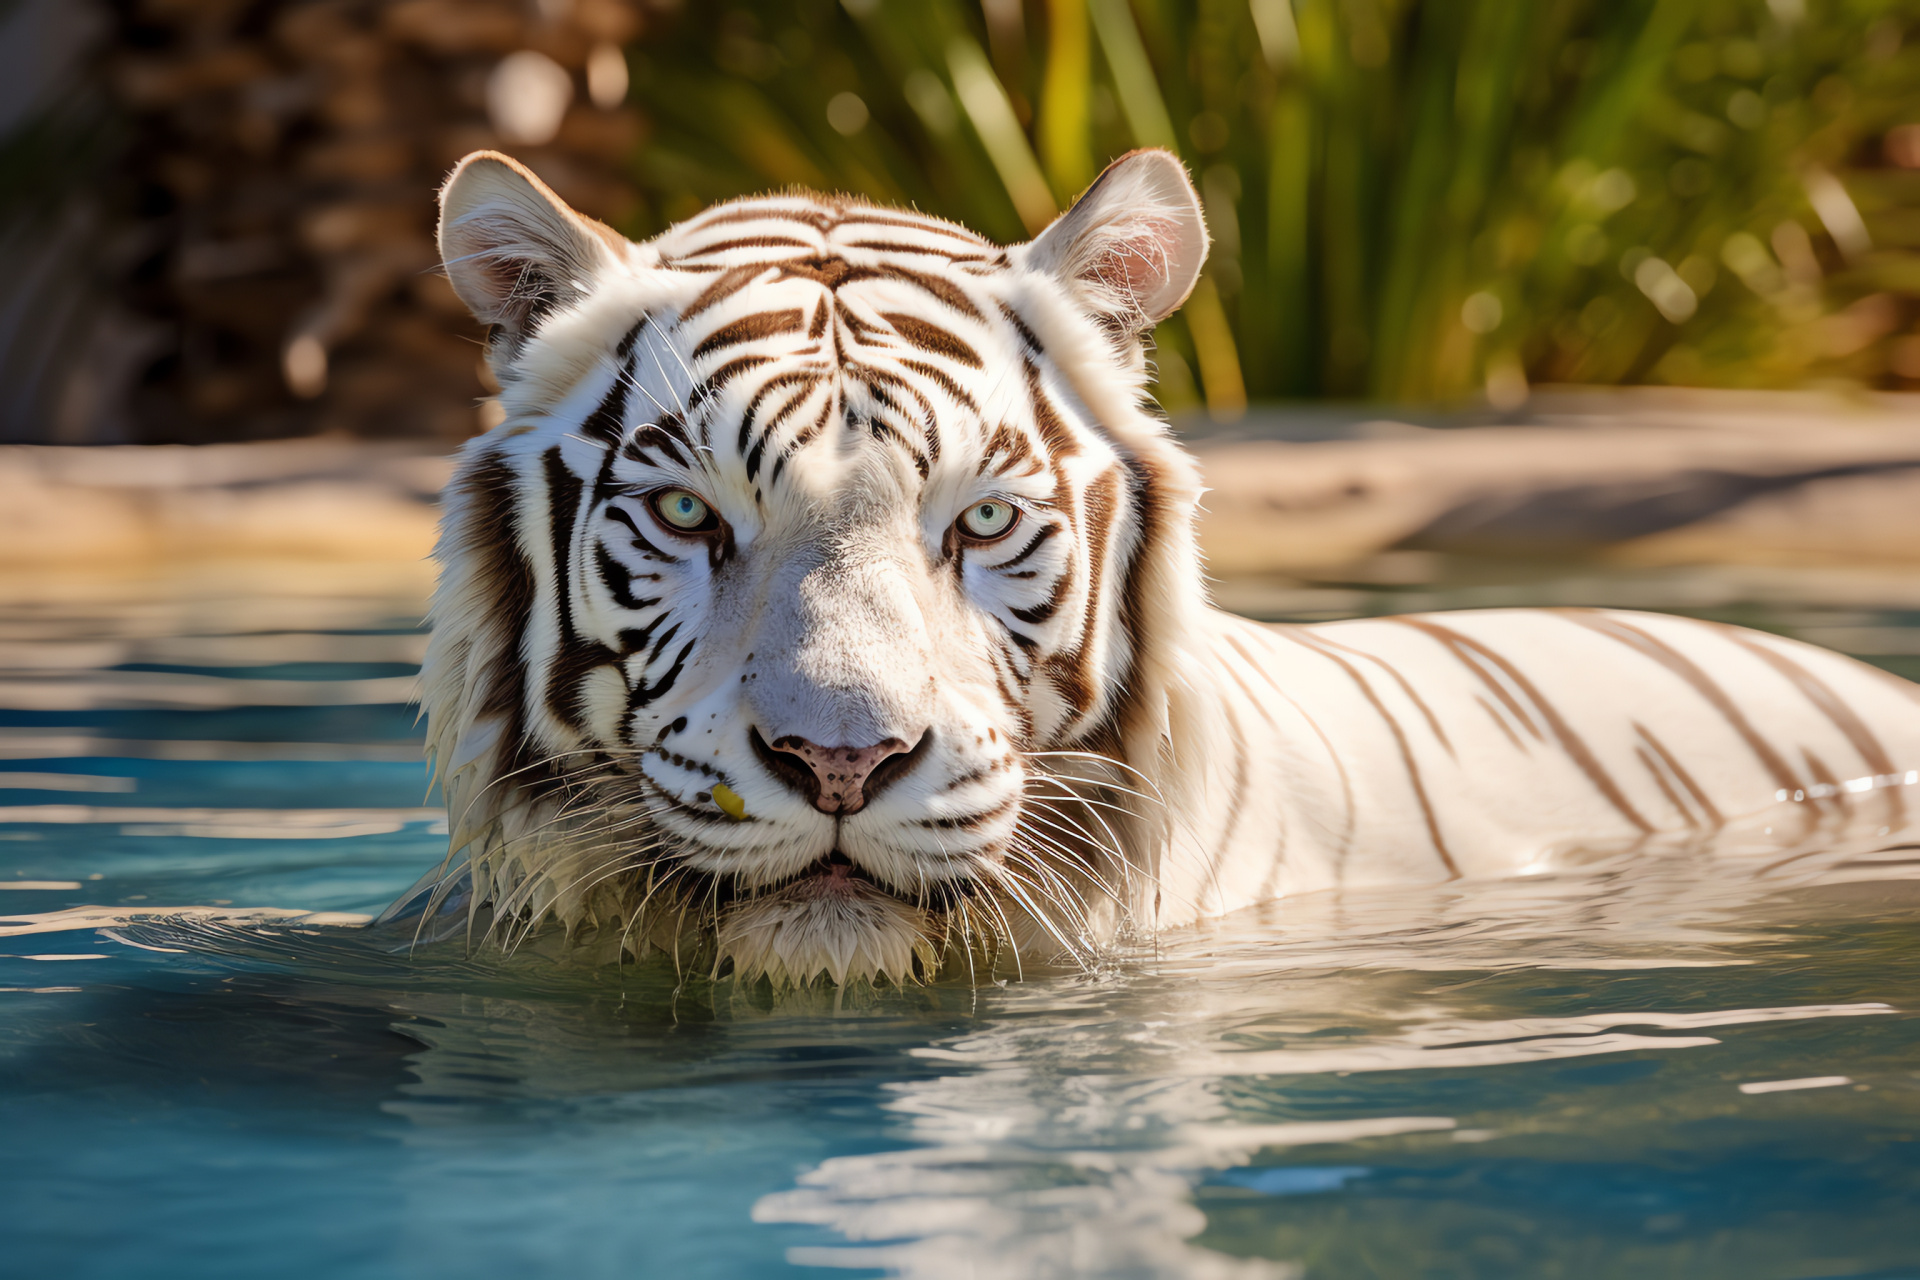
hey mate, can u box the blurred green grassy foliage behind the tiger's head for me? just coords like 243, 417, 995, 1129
628, 0, 1920, 416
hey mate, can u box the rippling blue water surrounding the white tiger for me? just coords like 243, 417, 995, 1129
0, 557, 1920, 1280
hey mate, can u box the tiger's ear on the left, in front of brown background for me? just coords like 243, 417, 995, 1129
440, 152, 620, 361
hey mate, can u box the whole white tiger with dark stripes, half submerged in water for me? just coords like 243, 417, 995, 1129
390, 152, 1920, 983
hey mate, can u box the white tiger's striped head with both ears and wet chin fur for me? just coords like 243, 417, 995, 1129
424, 152, 1206, 983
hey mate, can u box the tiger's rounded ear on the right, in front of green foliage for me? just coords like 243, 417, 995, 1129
1025, 148, 1208, 338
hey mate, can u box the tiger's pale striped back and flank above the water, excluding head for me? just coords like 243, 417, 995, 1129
1167, 608, 1920, 913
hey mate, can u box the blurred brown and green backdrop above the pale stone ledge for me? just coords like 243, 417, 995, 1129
0, 0, 1920, 443
